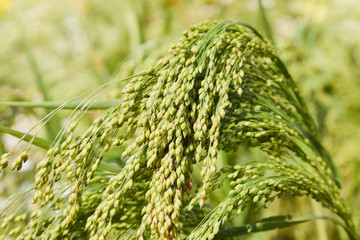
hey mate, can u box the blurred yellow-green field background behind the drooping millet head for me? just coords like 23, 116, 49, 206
0, 0, 360, 239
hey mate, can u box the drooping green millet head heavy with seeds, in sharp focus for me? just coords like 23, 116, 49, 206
0, 21, 359, 240
